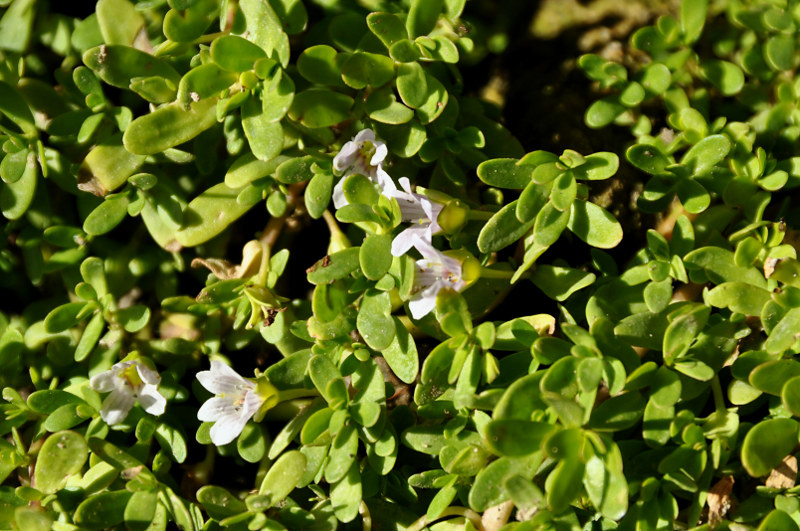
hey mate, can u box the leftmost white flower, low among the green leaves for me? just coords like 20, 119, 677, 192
89, 361, 167, 426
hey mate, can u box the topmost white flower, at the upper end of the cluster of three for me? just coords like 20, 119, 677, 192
333, 129, 397, 208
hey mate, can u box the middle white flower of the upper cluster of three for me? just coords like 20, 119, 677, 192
388, 177, 444, 256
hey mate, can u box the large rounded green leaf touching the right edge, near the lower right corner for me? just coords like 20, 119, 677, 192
742, 419, 797, 477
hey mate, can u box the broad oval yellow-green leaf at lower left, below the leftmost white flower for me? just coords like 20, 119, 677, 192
35, 431, 89, 494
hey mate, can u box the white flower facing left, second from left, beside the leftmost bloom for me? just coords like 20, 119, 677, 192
197, 360, 264, 446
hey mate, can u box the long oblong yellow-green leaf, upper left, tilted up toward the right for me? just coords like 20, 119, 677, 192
122, 98, 217, 155
